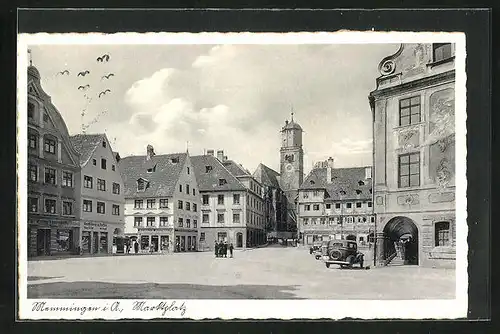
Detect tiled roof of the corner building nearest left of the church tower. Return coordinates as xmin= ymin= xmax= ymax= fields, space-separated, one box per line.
xmin=191 ymin=155 xmax=246 ymax=191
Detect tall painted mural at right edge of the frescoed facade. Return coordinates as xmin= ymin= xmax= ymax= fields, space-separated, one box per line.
xmin=426 ymin=88 xmax=455 ymax=190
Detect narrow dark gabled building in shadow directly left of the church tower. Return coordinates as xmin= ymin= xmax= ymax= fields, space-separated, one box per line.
xmin=253 ymin=163 xmax=295 ymax=240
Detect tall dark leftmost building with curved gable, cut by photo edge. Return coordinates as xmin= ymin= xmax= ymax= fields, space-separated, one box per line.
xmin=27 ymin=66 xmax=80 ymax=257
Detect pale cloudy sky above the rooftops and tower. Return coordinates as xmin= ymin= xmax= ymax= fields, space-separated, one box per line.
xmin=30 ymin=44 xmax=399 ymax=172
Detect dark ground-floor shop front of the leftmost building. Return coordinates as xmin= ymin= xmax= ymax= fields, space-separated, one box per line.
xmin=28 ymin=219 xmax=79 ymax=257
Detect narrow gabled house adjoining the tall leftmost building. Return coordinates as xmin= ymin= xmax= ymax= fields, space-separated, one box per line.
xmin=70 ymin=134 xmax=125 ymax=254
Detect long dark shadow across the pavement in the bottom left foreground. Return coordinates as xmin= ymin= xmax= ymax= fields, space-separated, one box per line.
xmin=27 ymin=282 xmax=303 ymax=299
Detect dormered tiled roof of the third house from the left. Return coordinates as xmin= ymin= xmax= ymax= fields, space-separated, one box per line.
xmin=118 ymin=153 xmax=187 ymax=198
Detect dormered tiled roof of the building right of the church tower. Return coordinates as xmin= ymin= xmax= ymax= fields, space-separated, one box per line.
xmin=300 ymin=167 xmax=372 ymax=200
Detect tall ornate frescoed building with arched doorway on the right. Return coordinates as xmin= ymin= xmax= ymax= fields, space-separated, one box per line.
xmin=369 ymin=43 xmax=456 ymax=267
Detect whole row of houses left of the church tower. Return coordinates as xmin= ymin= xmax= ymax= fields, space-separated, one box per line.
xmin=28 ymin=66 xmax=290 ymax=257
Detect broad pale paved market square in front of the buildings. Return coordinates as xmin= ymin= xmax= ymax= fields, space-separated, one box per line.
xmin=28 ymin=247 xmax=455 ymax=299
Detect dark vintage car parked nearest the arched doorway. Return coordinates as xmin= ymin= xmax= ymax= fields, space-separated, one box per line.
xmin=322 ymin=240 xmax=364 ymax=268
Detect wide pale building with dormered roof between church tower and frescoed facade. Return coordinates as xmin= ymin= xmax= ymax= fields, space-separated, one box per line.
xmin=298 ymin=158 xmax=375 ymax=245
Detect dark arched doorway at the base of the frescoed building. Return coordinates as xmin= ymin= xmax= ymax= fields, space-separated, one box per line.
xmin=384 ymin=216 xmax=419 ymax=265
